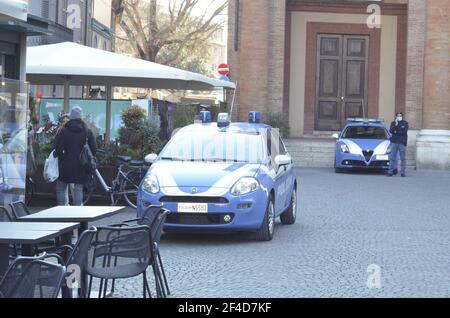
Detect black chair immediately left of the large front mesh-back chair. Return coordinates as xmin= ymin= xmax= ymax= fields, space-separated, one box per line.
xmin=48 ymin=227 xmax=97 ymax=298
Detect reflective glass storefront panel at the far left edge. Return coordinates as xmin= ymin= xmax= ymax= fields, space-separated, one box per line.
xmin=0 ymin=78 xmax=28 ymax=205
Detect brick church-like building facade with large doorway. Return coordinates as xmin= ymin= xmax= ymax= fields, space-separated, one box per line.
xmin=228 ymin=0 xmax=450 ymax=169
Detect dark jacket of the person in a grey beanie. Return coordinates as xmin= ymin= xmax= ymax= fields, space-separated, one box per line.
xmin=55 ymin=119 xmax=97 ymax=184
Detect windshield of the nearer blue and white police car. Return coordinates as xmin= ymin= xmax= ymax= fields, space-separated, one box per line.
xmin=160 ymin=130 xmax=266 ymax=163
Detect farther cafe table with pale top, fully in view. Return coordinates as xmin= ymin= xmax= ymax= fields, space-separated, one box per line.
xmin=19 ymin=206 xmax=125 ymax=234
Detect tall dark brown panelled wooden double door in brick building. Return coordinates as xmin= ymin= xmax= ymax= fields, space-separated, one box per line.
xmin=315 ymin=34 xmax=369 ymax=131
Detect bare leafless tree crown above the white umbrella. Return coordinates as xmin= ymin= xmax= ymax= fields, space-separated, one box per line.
xmin=117 ymin=0 xmax=228 ymax=72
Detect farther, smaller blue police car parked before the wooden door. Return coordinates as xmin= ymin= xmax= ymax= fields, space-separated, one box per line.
xmin=335 ymin=118 xmax=390 ymax=173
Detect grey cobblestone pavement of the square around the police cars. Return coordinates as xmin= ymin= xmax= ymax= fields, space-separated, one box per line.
xmin=34 ymin=169 xmax=450 ymax=297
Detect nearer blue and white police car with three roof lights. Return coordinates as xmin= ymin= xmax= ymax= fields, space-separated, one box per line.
xmin=138 ymin=112 xmax=298 ymax=241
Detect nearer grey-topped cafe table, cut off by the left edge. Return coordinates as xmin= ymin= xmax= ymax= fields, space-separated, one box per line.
xmin=0 ymin=222 xmax=79 ymax=275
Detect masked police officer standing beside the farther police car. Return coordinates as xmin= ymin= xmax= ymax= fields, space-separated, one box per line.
xmin=388 ymin=113 xmax=409 ymax=178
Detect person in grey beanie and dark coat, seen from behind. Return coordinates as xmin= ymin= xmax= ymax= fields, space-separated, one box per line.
xmin=55 ymin=106 xmax=97 ymax=206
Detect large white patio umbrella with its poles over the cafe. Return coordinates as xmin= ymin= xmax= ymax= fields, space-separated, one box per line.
xmin=27 ymin=42 xmax=236 ymax=138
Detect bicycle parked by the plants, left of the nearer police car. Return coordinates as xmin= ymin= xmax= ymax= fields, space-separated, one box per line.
xmin=84 ymin=150 xmax=148 ymax=208
